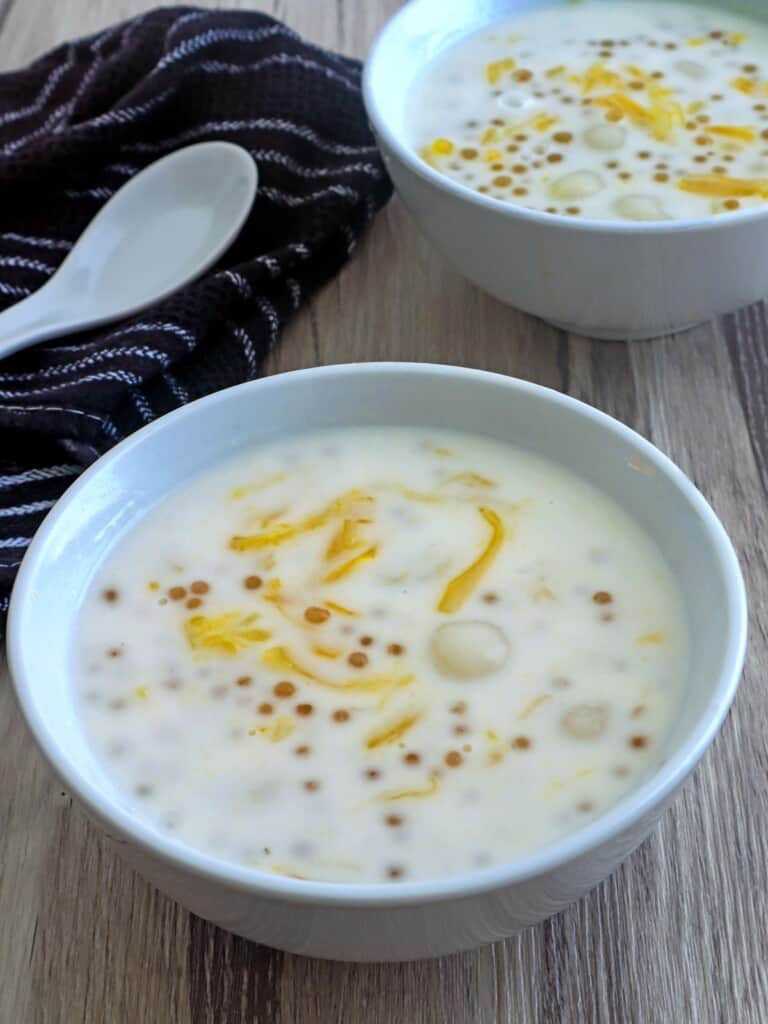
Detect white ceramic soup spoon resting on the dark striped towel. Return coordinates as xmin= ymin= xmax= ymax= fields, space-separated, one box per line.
xmin=0 ymin=142 xmax=258 ymax=358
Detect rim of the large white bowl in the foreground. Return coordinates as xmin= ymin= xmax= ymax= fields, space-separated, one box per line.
xmin=7 ymin=361 xmax=748 ymax=907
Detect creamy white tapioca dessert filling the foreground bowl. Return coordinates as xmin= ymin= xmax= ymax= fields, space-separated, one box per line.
xmin=73 ymin=428 xmax=687 ymax=883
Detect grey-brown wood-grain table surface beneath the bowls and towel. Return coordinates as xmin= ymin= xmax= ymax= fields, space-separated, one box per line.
xmin=0 ymin=0 xmax=768 ymax=1024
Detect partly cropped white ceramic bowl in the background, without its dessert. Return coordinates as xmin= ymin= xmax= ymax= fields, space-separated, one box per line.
xmin=364 ymin=0 xmax=768 ymax=339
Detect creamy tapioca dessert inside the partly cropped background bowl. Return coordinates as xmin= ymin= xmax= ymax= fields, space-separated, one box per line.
xmin=410 ymin=0 xmax=768 ymax=221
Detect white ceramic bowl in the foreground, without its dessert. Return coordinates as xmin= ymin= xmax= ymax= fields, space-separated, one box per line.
xmin=8 ymin=364 xmax=746 ymax=961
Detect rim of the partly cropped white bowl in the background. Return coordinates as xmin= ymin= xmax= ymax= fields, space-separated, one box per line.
xmin=362 ymin=0 xmax=768 ymax=236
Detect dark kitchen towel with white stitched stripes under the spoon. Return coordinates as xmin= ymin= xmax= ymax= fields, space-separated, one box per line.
xmin=0 ymin=7 xmax=390 ymax=620
